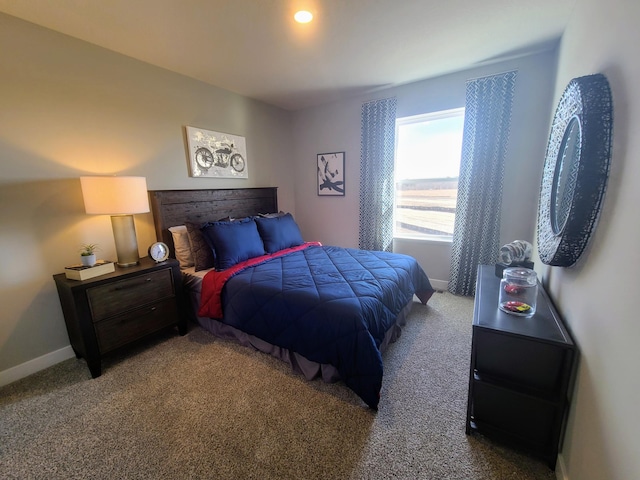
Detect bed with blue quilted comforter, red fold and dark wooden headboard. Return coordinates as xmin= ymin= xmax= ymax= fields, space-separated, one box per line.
xmin=150 ymin=188 xmax=433 ymax=409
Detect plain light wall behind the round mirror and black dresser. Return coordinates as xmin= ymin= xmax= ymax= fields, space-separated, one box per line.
xmin=541 ymin=0 xmax=640 ymax=480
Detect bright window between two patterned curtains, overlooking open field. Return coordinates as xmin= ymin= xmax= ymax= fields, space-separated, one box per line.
xmin=393 ymin=108 xmax=464 ymax=241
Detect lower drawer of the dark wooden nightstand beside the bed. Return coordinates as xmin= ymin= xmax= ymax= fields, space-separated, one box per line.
xmin=94 ymin=298 xmax=178 ymax=353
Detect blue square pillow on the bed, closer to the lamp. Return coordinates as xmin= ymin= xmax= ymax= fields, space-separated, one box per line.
xmin=201 ymin=219 xmax=265 ymax=270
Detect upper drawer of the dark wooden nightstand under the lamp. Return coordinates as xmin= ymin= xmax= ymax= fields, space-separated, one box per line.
xmin=87 ymin=268 xmax=174 ymax=322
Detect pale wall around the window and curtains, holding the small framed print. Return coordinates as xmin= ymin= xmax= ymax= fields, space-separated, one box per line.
xmin=293 ymin=50 xmax=556 ymax=288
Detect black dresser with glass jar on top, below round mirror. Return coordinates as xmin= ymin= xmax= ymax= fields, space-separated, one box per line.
xmin=466 ymin=265 xmax=577 ymax=469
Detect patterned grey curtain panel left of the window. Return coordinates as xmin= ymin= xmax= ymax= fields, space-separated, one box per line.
xmin=358 ymin=98 xmax=397 ymax=252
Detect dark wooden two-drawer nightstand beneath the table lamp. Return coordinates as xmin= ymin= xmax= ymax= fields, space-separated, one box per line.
xmin=53 ymin=257 xmax=187 ymax=378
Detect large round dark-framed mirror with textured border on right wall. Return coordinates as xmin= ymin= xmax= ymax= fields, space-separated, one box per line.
xmin=538 ymin=74 xmax=613 ymax=267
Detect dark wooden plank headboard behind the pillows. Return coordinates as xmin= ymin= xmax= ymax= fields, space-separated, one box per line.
xmin=149 ymin=187 xmax=278 ymax=258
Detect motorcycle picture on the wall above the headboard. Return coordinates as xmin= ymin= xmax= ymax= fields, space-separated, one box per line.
xmin=186 ymin=127 xmax=249 ymax=178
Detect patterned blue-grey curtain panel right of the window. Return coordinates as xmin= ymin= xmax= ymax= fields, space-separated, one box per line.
xmin=449 ymin=71 xmax=517 ymax=295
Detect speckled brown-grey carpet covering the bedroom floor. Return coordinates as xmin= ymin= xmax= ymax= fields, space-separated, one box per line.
xmin=0 ymin=293 xmax=555 ymax=480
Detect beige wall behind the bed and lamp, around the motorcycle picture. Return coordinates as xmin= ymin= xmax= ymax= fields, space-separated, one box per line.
xmin=0 ymin=14 xmax=295 ymax=378
